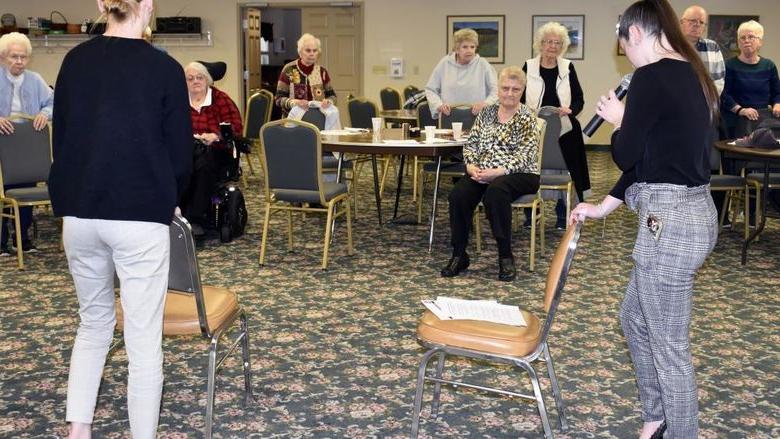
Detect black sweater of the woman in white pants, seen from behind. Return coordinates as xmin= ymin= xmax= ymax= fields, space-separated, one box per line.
xmin=49 ymin=36 xmax=193 ymax=224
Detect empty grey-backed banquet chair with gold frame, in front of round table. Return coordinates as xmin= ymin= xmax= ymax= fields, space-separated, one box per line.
xmin=260 ymin=119 xmax=353 ymax=270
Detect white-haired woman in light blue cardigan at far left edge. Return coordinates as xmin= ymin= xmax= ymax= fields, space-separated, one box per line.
xmin=0 ymin=32 xmax=54 ymax=256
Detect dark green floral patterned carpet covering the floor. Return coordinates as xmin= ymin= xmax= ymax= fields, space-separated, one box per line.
xmin=0 ymin=152 xmax=780 ymax=438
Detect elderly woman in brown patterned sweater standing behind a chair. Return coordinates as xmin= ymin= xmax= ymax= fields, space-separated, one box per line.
xmin=274 ymin=33 xmax=341 ymax=130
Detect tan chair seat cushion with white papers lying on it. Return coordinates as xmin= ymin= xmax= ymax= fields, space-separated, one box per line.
xmin=417 ymin=309 xmax=542 ymax=357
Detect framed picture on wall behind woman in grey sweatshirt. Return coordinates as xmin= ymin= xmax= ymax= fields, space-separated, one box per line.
xmin=447 ymin=15 xmax=505 ymax=64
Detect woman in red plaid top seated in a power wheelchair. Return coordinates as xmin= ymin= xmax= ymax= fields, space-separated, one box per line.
xmin=179 ymin=61 xmax=244 ymax=235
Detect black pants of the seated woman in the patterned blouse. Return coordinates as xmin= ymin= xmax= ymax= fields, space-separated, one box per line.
xmin=449 ymin=174 xmax=539 ymax=258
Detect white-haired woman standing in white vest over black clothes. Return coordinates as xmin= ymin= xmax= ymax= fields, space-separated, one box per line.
xmin=521 ymin=21 xmax=590 ymax=229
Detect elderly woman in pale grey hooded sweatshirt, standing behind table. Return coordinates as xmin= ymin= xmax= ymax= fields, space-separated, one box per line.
xmin=425 ymin=28 xmax=497 ymax=119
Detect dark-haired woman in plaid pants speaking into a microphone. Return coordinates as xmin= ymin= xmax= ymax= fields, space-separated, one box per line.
xmin=571 ymin=0 xmax=718 ymax=439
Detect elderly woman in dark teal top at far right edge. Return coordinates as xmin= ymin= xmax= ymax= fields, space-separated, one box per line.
xmin=721 ymin=20 xmax=780 ymax=138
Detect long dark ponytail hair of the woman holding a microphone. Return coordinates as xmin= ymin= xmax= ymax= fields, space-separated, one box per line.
xmin=618 ymin=0 xmax=720 ymax=121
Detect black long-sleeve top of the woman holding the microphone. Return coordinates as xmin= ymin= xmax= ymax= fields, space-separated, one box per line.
xmin=610 ymin=58 xmax=713 ymax=200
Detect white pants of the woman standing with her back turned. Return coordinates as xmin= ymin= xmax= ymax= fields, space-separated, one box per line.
xmin=63 ymin=217 xmax=170 ymax=439
